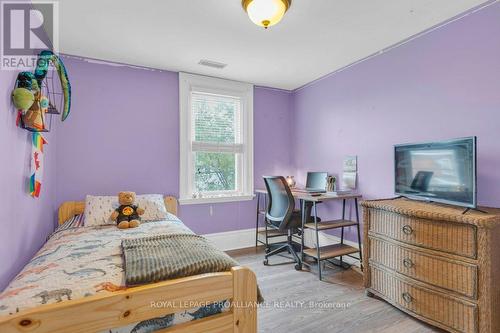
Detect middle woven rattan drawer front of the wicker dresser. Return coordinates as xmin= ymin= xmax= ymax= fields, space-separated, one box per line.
xmin=370 ymin=237 xmax=477 ymax=299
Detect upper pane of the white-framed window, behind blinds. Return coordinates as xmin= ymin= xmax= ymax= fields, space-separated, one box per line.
xmin=191 ymin=93 xmax=240 ymax=143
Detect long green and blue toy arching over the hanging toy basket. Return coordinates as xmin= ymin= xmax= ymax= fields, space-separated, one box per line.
xmin=35 ymin=50 xmax=71 ymax=121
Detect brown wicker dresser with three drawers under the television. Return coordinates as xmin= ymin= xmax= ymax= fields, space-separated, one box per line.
xmin=362 ymin=199 xmax=500 ymax=333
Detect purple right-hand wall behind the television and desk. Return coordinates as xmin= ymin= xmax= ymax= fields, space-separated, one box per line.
xmin=293 ymin=4 xmax=500 ymax=239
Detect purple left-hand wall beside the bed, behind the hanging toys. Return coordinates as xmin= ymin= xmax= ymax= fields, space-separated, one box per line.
xmin=0 ymin=70 xmax=57 ymax=290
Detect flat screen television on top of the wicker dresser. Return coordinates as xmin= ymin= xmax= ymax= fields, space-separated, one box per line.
xmin=394 ymin=137 xmax=477 ymax=208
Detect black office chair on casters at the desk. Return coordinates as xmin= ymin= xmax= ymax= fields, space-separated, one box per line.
xmin=263 ymin=176 xmax=302 ymax=270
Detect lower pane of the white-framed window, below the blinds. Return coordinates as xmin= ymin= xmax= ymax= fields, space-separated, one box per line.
xmin=194 ymin=152 xmax=236 ymax=192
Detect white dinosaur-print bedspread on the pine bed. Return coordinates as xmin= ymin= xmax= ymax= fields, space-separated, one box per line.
xmin=0 ymin=215 xmax=226 ymax=333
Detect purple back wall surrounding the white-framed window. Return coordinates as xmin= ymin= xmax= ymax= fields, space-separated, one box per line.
xmin=57 ymin=57 xmax=291 ymax=234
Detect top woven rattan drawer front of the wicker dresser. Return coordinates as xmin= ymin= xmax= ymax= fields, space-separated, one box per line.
xmin=370 ymin=209 xmax=477 ymax=258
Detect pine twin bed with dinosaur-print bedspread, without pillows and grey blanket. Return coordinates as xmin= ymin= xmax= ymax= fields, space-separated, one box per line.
xmin=0 ymin=197 xmax=257 ymax=333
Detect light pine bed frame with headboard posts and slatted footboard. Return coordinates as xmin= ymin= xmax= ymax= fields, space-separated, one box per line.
xmin=0 ymin=197 xmax=257 ymax=333
